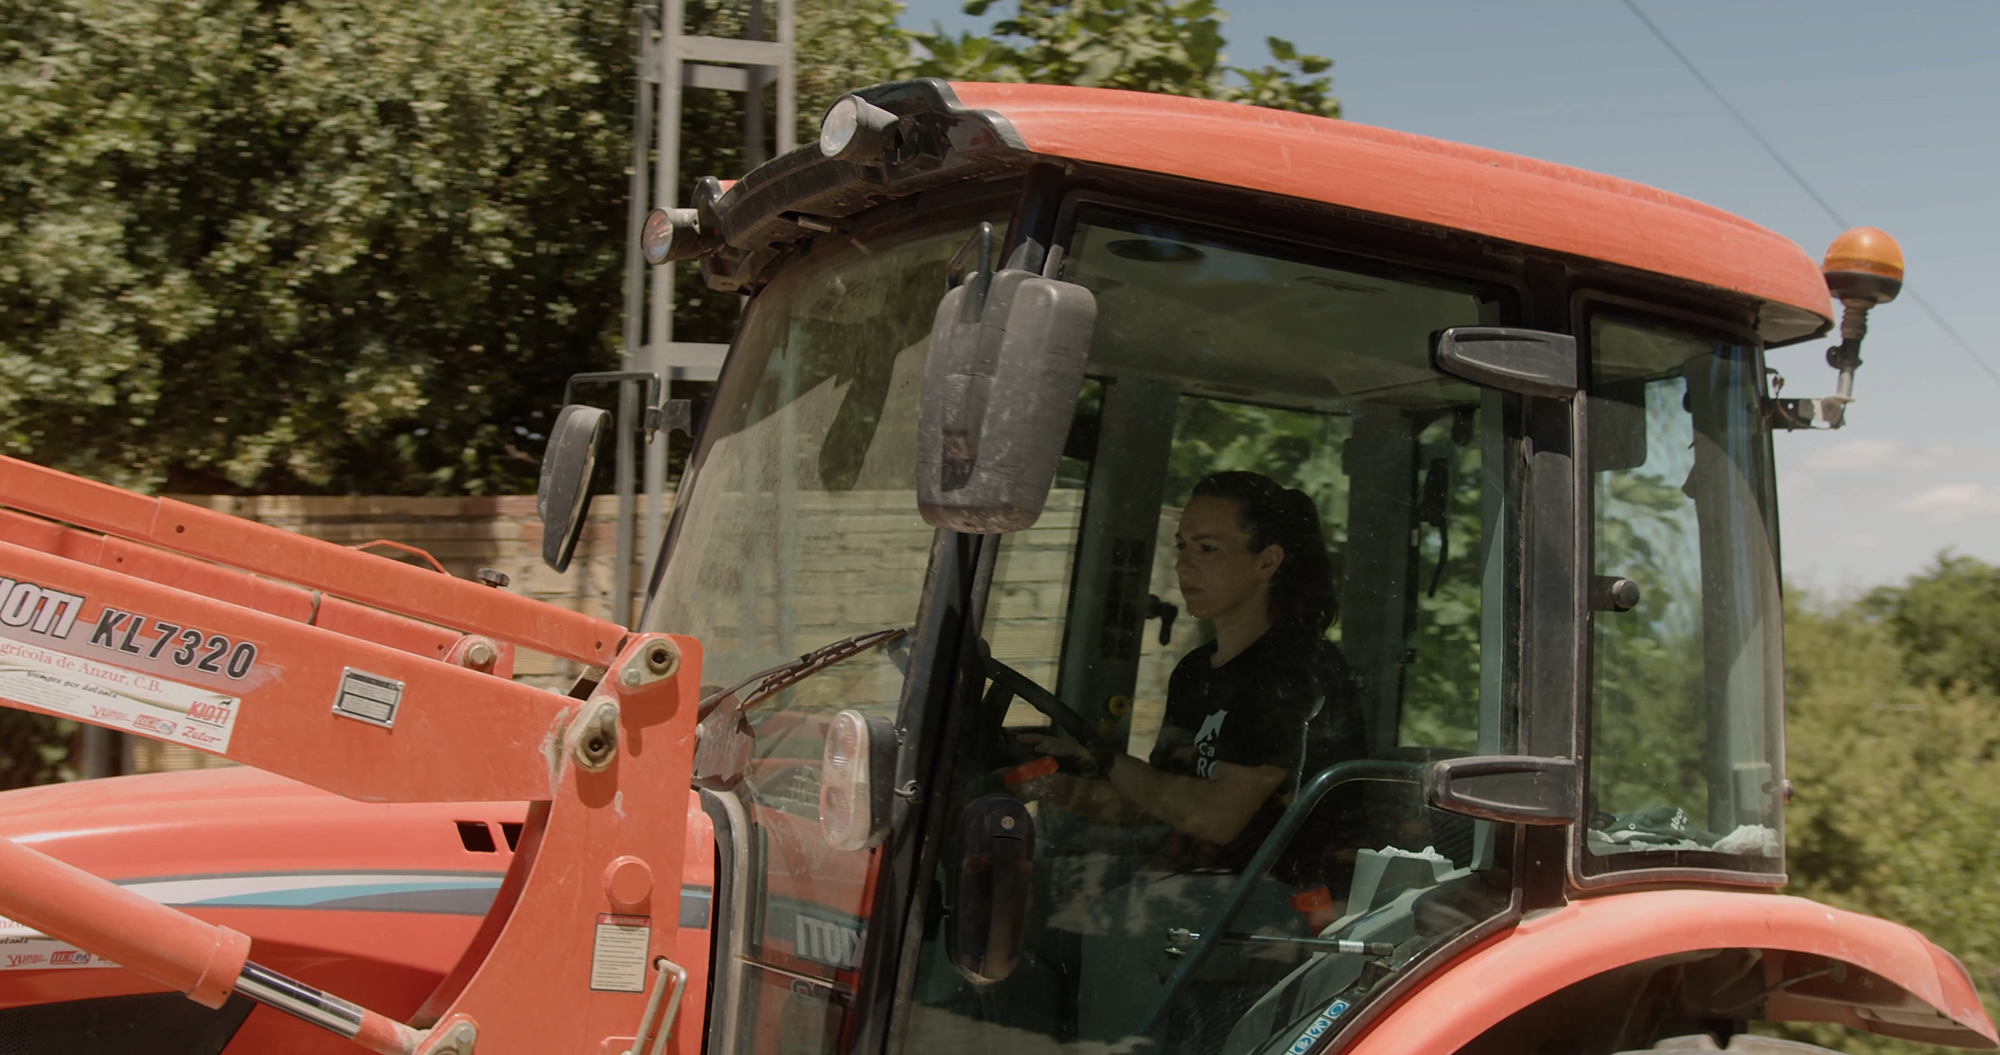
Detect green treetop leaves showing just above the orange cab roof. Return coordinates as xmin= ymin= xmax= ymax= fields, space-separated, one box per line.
xmin=914 ymin=0 xmax=1340 ymax=118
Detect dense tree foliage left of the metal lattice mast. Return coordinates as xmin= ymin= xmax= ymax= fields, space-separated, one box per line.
xmin=0 ymin=0 xmax=632 ymax=494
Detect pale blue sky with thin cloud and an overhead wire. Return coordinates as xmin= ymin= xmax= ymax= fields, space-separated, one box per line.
xmin=904 ymin=0 xmax=2000 ymax=597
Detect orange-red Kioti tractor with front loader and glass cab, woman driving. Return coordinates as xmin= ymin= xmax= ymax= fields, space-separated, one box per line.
xmin=0 ymin=80 xmax=1996 ymax=1055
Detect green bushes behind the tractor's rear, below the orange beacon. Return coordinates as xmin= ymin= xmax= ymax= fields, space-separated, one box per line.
xmin=1786 ymin=575 xmax=2000 ymax=1055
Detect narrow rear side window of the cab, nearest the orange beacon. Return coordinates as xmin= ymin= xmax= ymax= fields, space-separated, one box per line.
xmin=1588 ymin=318 xmax=1784 ymax=871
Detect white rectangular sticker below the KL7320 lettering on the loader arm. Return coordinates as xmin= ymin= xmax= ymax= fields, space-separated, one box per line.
xmin=0 ymin=639 xmax=240 ymax=753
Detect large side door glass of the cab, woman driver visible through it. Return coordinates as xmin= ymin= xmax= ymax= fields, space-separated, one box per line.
xmin=910 ymin=212 xmax=1514 ymax=1055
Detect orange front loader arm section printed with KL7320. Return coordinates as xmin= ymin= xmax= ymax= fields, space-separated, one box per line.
xmin=0 ymin=541 xmax=580 ymax=801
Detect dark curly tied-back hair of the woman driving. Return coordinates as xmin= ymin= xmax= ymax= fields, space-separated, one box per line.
xmin=1190 ymin=470 xmax=1340 ymax=633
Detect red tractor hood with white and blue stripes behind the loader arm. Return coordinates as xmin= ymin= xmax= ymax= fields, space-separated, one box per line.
xmin=0 ymin=767 xmax=714 ymax=1053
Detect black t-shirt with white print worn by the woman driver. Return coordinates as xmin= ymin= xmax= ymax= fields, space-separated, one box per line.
xmin=1148 ymin=627 xmax=1364 ymax=869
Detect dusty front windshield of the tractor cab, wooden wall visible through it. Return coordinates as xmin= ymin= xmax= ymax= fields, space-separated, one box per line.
xmin=646 ymin=205 xmax=1008 ymax=1055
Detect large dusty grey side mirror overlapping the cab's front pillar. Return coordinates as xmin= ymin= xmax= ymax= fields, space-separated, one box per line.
xmin=916 ymin=224 xmax=1098 ymax=535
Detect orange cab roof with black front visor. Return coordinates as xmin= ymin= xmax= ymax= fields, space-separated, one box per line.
xmin=694 ymin=80 xmax=1830 ymax=344
